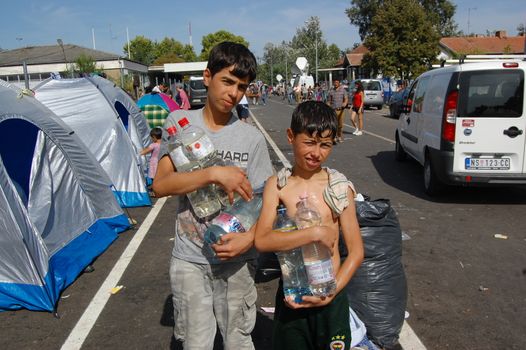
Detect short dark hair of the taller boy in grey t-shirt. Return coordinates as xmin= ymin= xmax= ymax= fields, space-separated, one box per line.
xmin=206 ymin=41 xmax=257 ymax=81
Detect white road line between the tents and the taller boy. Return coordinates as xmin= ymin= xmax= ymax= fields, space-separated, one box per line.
xmin=61 ymin=197 xmax=167 ymax=350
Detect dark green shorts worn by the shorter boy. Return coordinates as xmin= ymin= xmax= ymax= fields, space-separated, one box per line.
xmin=272 ymin=280 xmax=351 ymax=350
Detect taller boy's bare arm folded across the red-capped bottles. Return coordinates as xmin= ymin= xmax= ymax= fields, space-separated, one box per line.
xmin=153 ymin=156 xmax=252 ymax=200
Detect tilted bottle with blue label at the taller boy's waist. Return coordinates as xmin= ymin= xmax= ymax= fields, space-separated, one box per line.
xmin=204 ymin=191 xmax=263 ymax=244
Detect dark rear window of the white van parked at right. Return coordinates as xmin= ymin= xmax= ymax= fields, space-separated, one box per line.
xmin=458 ymin=70 xmax=524 ymax=118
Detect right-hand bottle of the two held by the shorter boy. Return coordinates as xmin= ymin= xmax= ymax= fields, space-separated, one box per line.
xmin=295 ymin=196 xmax=336 ymax=297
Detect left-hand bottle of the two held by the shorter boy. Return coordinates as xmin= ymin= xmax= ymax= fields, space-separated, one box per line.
xmin=274 ymin=205 xmax=312 ymax=303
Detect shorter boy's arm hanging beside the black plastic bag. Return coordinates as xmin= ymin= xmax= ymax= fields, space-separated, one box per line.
xmin=336 ymin=191 xmax=364 ymax=293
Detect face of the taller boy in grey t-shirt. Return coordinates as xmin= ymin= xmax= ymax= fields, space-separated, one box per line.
xmin=203 ymin=66 xmax=249 ymax=113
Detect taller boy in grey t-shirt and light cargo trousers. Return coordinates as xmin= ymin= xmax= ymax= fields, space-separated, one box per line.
xmin=153 ymin=41 xmax=273 ymax=350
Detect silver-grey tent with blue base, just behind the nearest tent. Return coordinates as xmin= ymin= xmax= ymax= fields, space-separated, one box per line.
xmin=35 ymin=78 xmax=151 ymax=207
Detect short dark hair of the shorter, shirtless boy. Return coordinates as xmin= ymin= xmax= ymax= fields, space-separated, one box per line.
xmin=290 ymin=101 xmax=338 ymax=139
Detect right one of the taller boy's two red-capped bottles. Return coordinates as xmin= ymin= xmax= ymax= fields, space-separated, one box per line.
xmin=178 ymin=117 xmax=223 ymax=218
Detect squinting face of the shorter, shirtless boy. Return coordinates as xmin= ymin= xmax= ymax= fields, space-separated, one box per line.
xmin=287 ymin=128 xmax=333 ymax=171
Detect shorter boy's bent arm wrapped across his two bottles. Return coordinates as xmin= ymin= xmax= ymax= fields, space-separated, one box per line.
xmin=255 ymin=176 xmax=337 ymax=252
